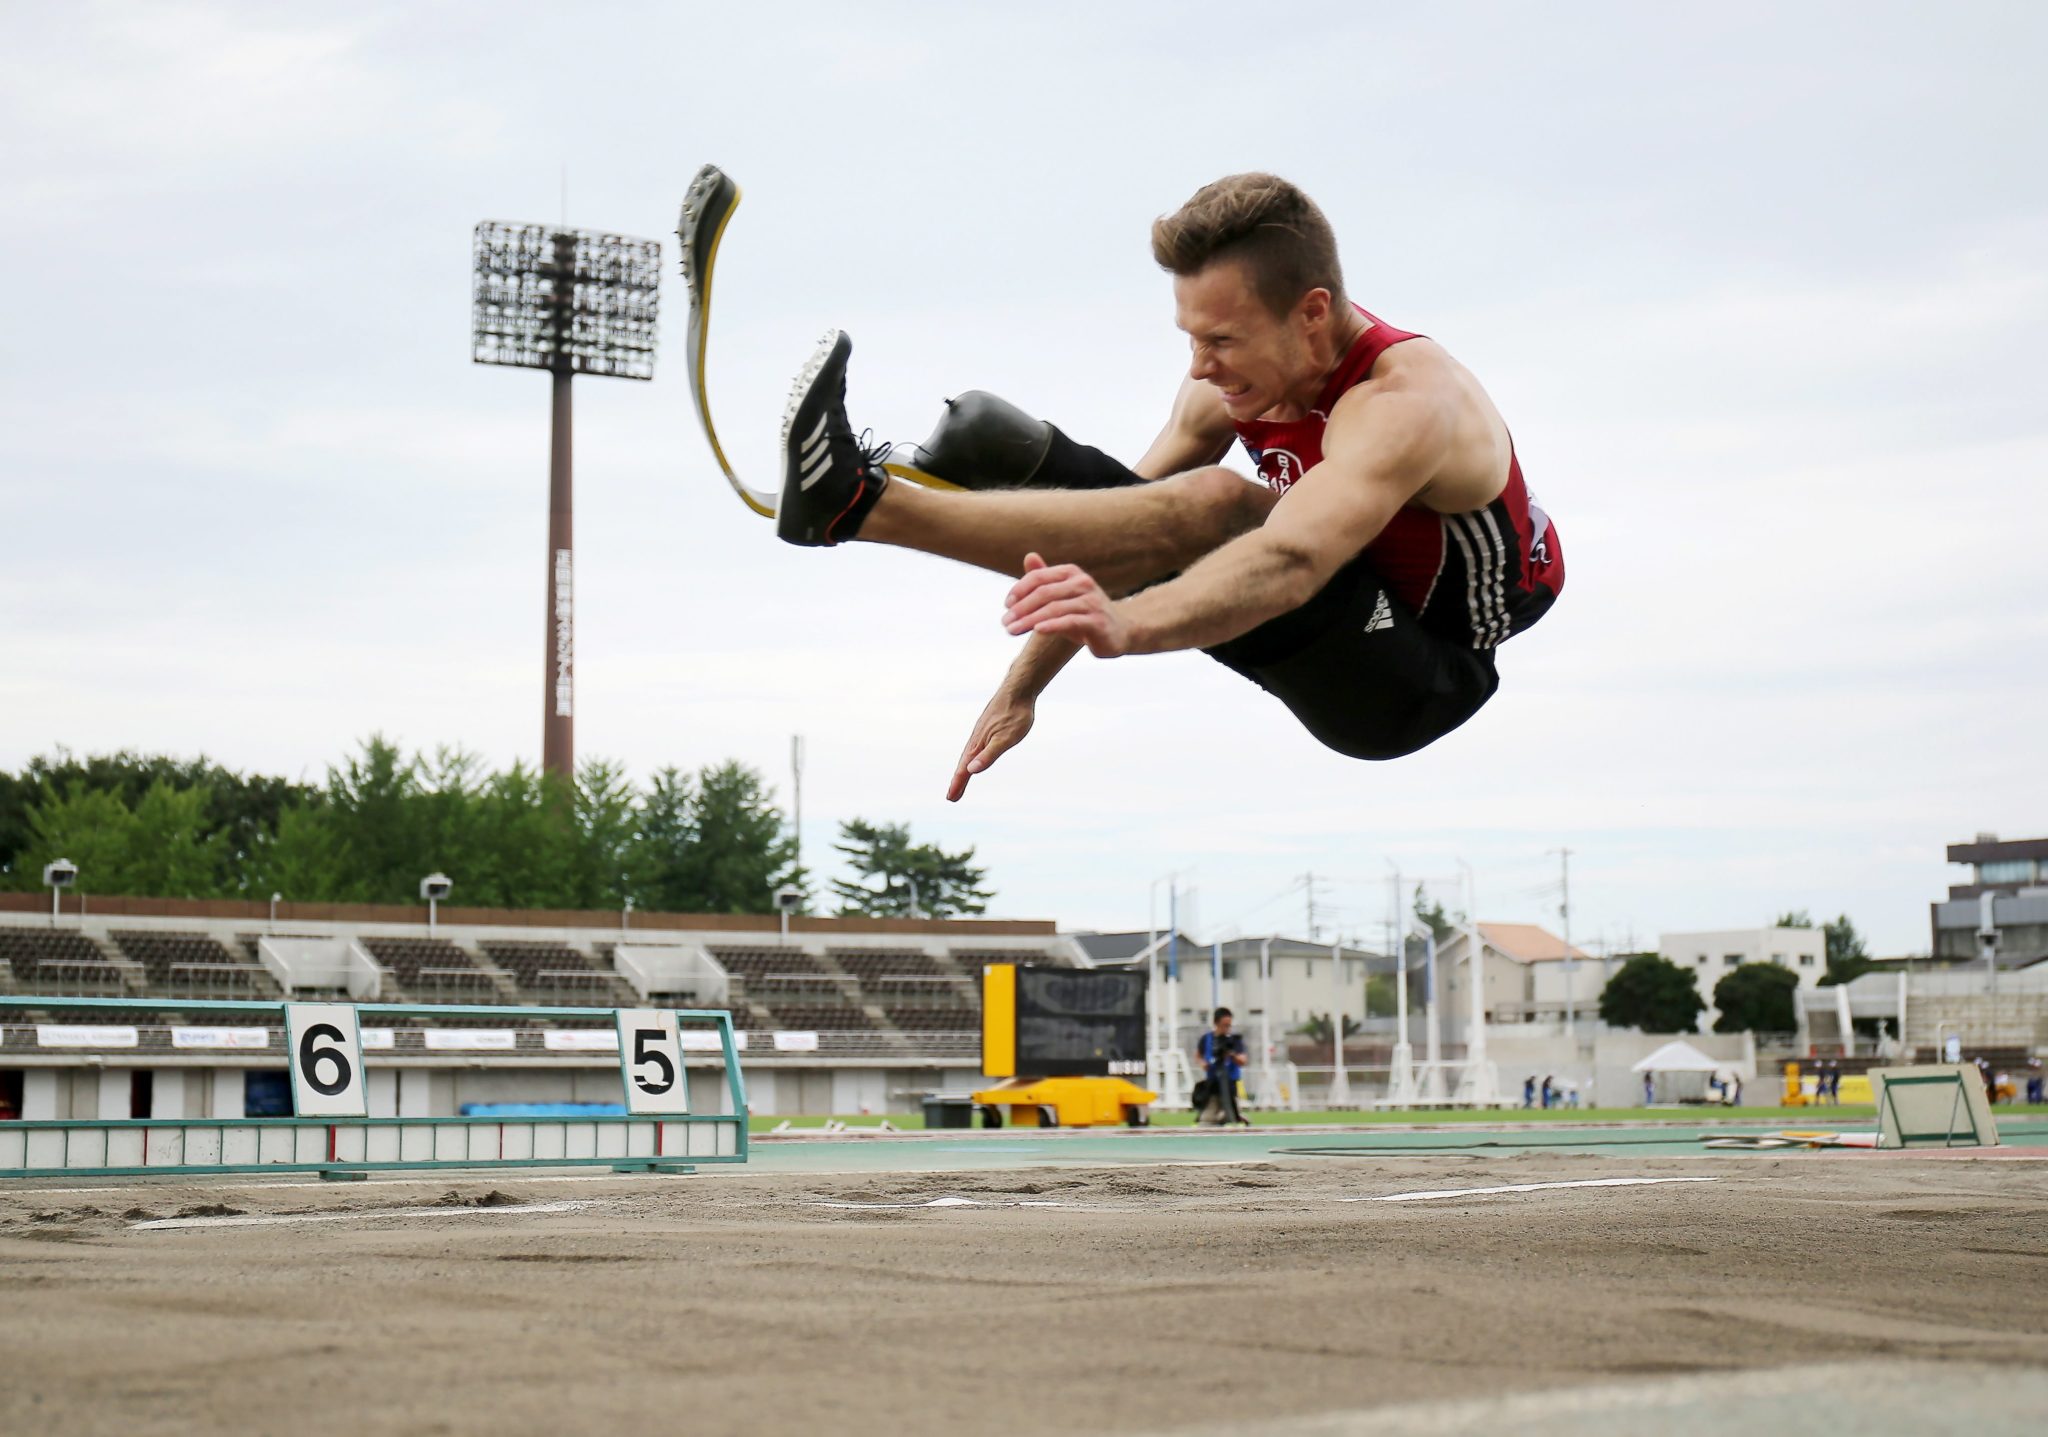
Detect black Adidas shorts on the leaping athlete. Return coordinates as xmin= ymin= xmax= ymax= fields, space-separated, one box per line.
xmin=1204 ymin=557 xmax=1501 ymax=759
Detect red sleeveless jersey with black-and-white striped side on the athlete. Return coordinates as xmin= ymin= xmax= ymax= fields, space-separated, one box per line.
xmin=1235 ymin=315 xmax=1565 ymax=649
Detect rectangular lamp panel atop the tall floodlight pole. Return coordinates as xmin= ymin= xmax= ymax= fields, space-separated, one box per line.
xmin=471 ymin=219 xmax=662 ymax=379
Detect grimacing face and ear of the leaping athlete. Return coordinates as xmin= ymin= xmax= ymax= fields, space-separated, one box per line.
xmin=1174 ymin=260 xmax=1329 ymax=422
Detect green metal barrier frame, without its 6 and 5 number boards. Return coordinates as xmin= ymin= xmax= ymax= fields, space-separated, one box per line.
xmin=0 ymin=997 xmax=748 ymax=1179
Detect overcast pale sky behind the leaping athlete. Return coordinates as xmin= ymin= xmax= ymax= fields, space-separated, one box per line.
xmin=0 ymin=2 xmax=2048 ymax=952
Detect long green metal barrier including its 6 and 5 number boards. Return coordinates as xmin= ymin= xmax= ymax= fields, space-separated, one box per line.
xmin=0 ymin=997 xmax=748 ymax=1179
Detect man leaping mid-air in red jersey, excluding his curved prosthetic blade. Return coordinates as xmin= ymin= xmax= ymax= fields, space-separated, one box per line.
xmin=776 ymin=174 xmax=1565 ymax=798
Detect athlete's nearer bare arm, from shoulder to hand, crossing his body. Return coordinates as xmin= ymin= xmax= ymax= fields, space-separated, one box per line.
xmin=1004 ymin=383 xmax=1456 ymax=659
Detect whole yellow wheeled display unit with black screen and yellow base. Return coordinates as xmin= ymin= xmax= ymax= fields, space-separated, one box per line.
xmin=975 ymin=962 xmax=1159 ymax=1128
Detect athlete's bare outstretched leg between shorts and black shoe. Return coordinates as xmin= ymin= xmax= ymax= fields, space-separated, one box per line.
xmin=858 ymin=469 xmax=1276 ymax=592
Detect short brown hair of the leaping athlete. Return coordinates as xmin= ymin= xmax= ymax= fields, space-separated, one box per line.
xmin=1153 ymin=174 xmax=1343 ymax=315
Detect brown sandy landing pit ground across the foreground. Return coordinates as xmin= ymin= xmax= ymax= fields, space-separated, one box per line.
xmin=0 ymin=1155 xmax=2048 ymax=1437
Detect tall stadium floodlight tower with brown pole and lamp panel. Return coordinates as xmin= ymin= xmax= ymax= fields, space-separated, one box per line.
xmin=471 ymin=219 xmax=662 ymax=778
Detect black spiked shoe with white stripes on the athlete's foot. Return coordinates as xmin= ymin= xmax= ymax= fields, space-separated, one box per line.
xmin=774 ymin=330 xmax=891 ymax=545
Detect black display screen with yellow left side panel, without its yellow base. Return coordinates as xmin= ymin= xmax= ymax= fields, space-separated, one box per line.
xmin=981 ymin=962 xmax=1147 ymax=1077
